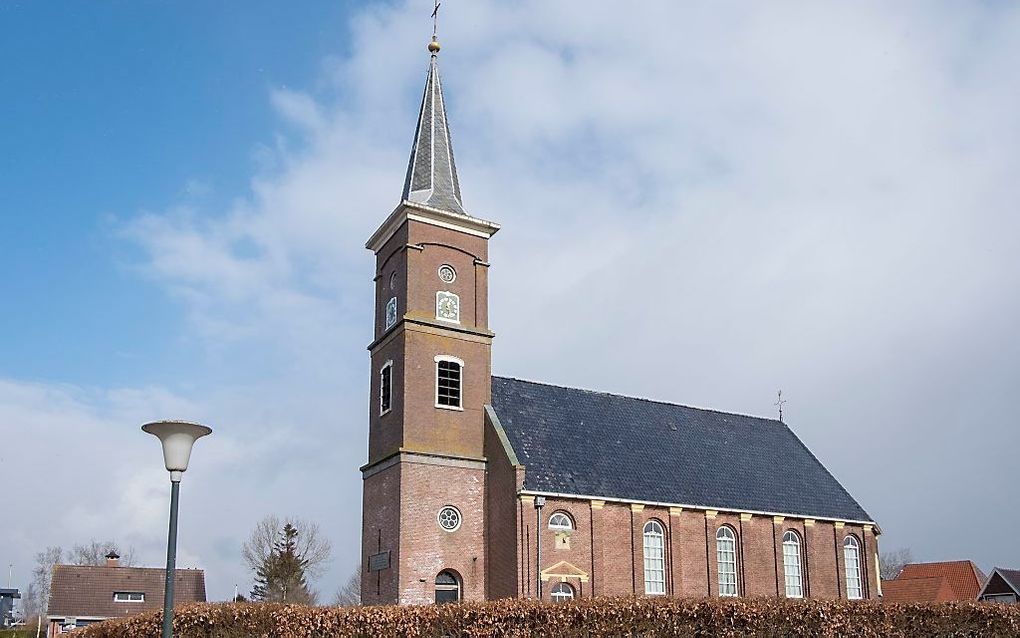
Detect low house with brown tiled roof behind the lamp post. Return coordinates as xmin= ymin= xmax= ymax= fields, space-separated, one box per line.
xmin=47 ymin=552 xmax=205 ymax=637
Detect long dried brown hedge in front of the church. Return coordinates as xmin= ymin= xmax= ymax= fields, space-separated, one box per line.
xmin=75 ymin=598 xmax=1020 ymax=638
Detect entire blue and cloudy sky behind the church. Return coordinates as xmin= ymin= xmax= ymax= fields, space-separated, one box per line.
xmin=0 ymin=0 xmax=1020 ymax=599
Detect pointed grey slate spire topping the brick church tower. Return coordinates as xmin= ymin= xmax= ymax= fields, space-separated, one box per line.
xmin=403 ymin=36 xmax=467 ymax=215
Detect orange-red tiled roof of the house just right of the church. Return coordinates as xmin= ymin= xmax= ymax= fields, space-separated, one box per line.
xmin=882 ymin=560 xmax=985 ymax=602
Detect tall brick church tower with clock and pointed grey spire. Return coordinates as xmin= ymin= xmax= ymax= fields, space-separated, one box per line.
xmin=361 ymin=37 xmax=499 ymax=604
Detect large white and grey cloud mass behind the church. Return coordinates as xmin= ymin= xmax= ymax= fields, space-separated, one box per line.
xmin=0 ymin=0 xmax=1020 ymax=597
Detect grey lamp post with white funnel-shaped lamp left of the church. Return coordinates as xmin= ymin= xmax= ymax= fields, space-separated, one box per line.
xmin=142 ymin=421 xmax=212 ymax=638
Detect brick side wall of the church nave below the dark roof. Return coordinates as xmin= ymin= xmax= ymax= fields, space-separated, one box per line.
xmin=517 ymin=494 xmax=877 ymax=600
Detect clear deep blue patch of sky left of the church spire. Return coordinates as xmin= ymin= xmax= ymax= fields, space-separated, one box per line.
xmin=0 ymin=2 xmax=359 ymax=385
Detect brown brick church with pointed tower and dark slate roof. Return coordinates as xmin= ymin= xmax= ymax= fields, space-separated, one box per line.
xmin=361 ymin=40 xmax=881 ymax=604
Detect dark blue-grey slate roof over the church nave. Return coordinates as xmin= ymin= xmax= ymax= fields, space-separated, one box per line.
xmin=492 ymin=377 xmax=871 ymax=521
